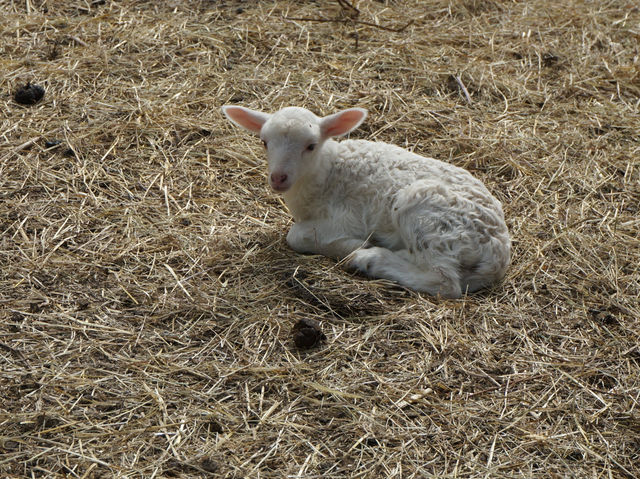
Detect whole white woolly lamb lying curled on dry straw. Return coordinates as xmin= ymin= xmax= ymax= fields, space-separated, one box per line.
xmin=222 ymin=105 xmax=511 ymax=298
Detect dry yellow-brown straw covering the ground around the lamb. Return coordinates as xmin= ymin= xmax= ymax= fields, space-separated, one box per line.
xmin=0 ymin=0 xmax=640 ymax=478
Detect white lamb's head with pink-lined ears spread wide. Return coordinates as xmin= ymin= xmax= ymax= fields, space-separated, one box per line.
xmin=222 ymin=106 xmax=367 ymax=193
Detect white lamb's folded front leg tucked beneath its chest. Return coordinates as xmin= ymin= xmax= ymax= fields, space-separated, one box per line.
xmin=287 ymin=221 xmax=367 ymax=260
